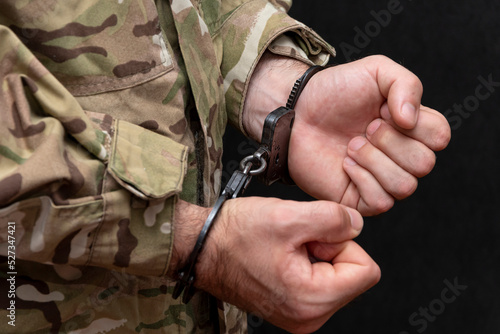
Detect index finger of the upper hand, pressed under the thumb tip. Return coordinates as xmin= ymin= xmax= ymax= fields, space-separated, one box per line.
xmin=380 ymin=104 xmax=451 ymax=151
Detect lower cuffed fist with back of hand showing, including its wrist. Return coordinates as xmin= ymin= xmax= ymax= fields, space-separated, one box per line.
xmin=171 ymin=197 xmax=380 ymax=333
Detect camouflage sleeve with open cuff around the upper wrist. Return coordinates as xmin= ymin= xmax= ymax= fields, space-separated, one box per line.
xmin=218 ymin=0 xmax=335 ymax=133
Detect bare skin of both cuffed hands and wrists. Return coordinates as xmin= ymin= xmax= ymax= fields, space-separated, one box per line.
xmin=169 ymin=54 xmax=450 ymax=333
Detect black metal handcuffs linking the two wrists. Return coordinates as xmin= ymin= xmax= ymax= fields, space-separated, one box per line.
xmin=172 ymin=65 xmax=325 ymax=304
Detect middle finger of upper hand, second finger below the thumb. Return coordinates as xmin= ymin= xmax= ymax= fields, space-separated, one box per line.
xmin=366 ymin=119 xmax=436 ymax=177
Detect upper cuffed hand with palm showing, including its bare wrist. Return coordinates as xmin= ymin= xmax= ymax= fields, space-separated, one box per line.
xmin=243 ymin=55 xmax=450 ymax=215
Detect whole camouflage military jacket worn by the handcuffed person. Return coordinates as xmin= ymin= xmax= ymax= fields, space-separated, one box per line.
xmin=0 ymin=0 xmax=333 ymax=333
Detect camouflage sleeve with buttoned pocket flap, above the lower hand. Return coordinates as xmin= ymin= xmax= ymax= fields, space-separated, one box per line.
xmin=0 ymin=26 xmax=187 ymax=275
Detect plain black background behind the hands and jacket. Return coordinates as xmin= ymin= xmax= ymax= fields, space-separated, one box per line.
xmin=224 ymin=0 xmax=500 ymax=334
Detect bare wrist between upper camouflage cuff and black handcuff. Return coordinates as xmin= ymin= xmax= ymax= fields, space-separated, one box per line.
xmin=243 ymin=52 xmax=309 ymax=141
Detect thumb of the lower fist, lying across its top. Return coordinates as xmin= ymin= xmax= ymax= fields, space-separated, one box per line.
xmin=288 ymin=201 xmax=363 ymax=245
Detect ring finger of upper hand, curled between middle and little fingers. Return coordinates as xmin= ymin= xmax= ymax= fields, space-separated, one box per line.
xmin=347 ymin=137 xmax=418 ymax=199
